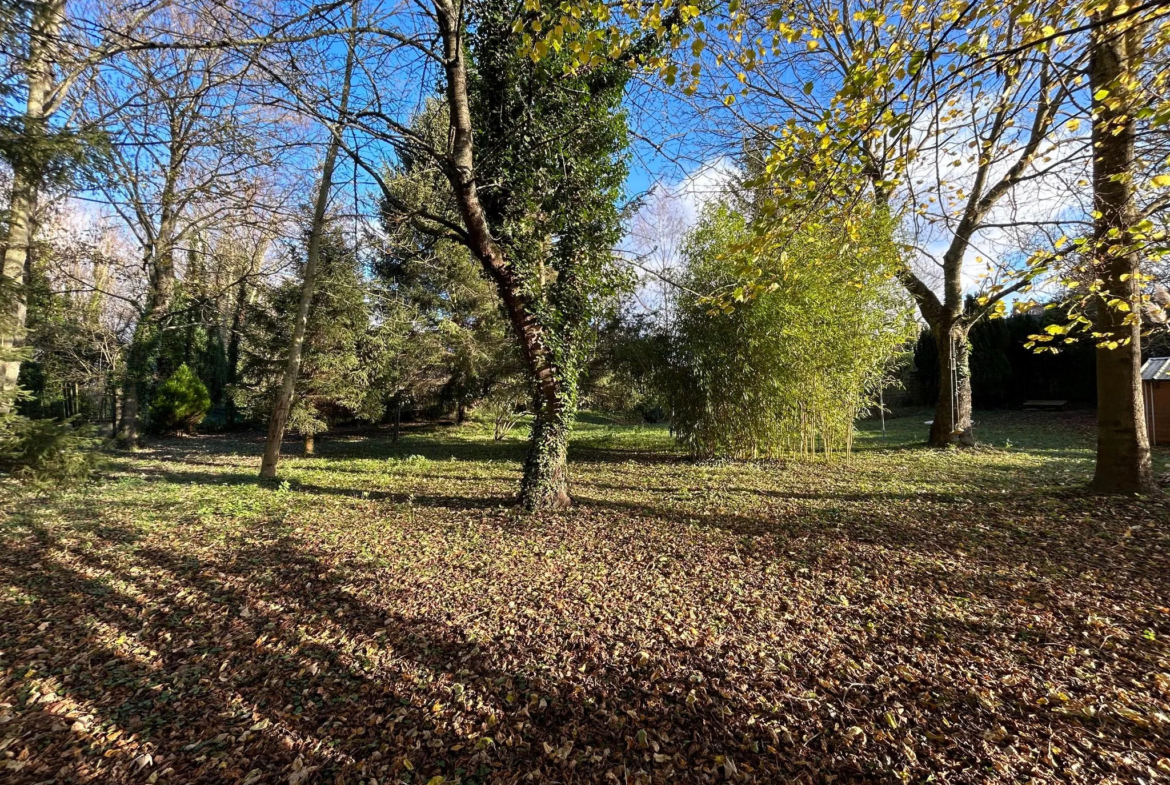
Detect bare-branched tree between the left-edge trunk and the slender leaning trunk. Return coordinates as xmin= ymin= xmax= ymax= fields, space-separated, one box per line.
xmin=85 ymin=11 xmax=280 ymax=449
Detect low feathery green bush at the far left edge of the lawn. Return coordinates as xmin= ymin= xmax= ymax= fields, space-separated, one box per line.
xmin=0 ymin=414 xmax=99 ymax=488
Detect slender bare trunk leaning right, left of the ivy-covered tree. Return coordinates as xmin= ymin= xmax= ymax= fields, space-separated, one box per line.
xmin=260 ymin=29 xmax=357 ymax=478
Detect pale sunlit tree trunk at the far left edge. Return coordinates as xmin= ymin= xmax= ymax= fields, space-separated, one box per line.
xmin=0 ymin=0 xmax=64 ymax=413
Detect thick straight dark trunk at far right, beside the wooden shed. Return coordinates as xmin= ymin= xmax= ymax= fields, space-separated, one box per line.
xmin=1089 ymin=9 xmax=1156 ymax=494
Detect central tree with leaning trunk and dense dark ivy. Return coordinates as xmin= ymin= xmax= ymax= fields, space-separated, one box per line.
xmin=348 ymin=0 xmax=631 ymax=509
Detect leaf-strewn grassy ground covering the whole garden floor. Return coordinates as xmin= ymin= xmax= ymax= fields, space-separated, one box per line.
xmin=0 ymin=413 xmax=1170 ymax=785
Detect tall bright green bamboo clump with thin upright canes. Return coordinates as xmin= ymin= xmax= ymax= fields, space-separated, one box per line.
xmin=668 ymin=205 xmax=914 ymax=459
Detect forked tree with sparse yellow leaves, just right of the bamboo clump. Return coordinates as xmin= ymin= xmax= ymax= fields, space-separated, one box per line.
xmin=716 ymin=0 xmax=1087 ymax=446
